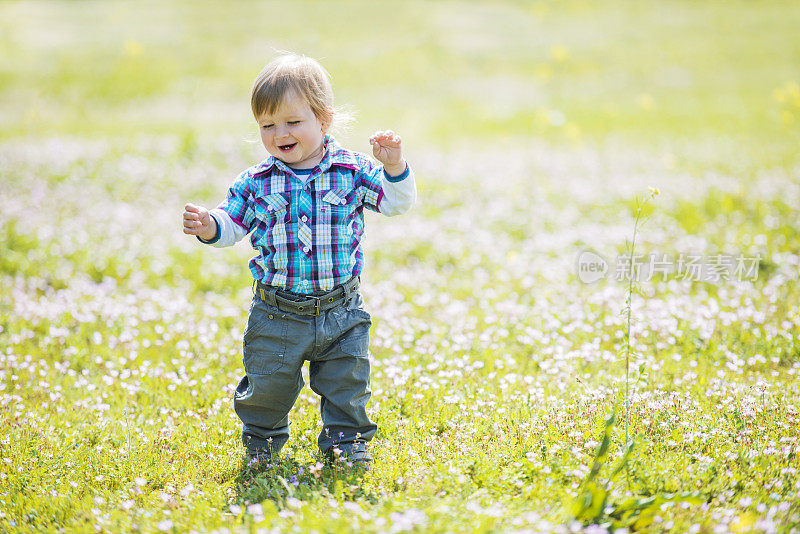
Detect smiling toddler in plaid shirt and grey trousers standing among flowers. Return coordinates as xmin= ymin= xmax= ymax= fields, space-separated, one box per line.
xmin=183 ymin=55 xmax=416 ymax=469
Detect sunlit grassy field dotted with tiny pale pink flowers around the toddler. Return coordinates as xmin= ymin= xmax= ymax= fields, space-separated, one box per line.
xmin=0 ymin=0 xmax=800 ymax=533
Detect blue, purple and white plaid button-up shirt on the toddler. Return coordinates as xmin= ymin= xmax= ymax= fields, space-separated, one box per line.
xmin=202 ymin=136 xmax=413 ymax=293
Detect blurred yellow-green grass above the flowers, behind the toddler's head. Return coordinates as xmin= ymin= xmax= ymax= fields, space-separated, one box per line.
xmin=0 ymin=1 xmax=800 ymax=146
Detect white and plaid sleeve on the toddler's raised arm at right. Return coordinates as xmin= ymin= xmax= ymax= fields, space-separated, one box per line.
xmin=357 ymin=161 xmax=417 ymax=217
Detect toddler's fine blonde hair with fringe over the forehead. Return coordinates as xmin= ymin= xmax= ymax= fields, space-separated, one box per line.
xmin=250 ymin=54 xmax=333 ymax=124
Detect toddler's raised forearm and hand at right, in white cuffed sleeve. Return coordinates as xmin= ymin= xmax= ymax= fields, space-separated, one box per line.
xmin=364 ymin=130 xmax=417 ymax=217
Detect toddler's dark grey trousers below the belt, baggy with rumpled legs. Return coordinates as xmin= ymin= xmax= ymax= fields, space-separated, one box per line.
xmin=233 ymin=291 xmax=377 ymax=456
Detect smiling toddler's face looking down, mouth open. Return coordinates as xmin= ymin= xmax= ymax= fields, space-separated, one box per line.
xmin=257 ymin=91 xmax=328 ymax=169
